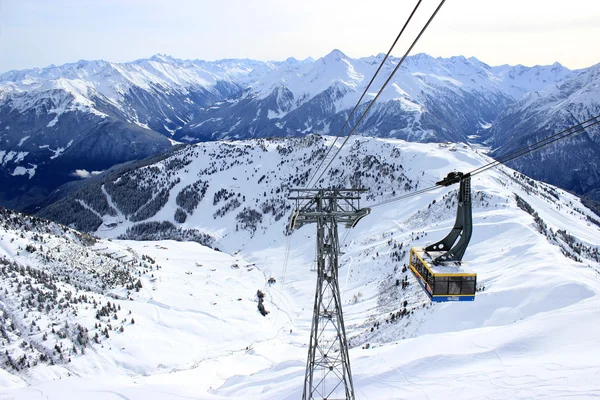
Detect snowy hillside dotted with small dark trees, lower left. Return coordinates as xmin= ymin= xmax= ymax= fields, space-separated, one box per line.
xmin=0 ymin=208 xmax=160 ymax=378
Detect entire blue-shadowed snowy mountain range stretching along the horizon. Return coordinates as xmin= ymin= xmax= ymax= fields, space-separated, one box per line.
xmin=0 ymin=50 xmax=600 ymax=209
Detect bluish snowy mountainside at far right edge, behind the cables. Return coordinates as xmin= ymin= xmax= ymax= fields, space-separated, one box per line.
xmin=486 ymin=64 xmax=600 ymax=195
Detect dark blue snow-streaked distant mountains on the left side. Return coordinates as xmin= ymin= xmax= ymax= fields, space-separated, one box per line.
xmin=0 ymin=55 xmax=269 ymax=209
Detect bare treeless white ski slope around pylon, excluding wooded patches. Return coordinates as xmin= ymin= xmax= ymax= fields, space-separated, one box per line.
xmin=0 ymin=138 xmax=600 ymax=399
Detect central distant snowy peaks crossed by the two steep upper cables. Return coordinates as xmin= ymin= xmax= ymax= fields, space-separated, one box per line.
xmin=175 ymin=50 xmax=572 ymax=142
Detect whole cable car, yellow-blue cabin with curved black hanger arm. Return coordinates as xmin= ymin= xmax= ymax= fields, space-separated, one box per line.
xmin=409 ymin=172 xmax=477 ymax=301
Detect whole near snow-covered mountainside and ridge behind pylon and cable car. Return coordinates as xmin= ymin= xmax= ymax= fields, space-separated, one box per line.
xmin=0 ymin=135 xmax=600 ymax=400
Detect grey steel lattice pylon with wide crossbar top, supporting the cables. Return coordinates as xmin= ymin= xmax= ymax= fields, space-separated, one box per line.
xmin=290 ymin=189 xmax=370 ymax=400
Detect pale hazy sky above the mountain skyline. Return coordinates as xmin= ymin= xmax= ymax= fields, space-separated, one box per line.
xmin=0 ymin=0 xmax=600 ymax=72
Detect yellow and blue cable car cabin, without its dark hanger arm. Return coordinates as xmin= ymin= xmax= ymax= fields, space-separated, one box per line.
xmin=409 ymin=247 xmax=477 ymax=301
